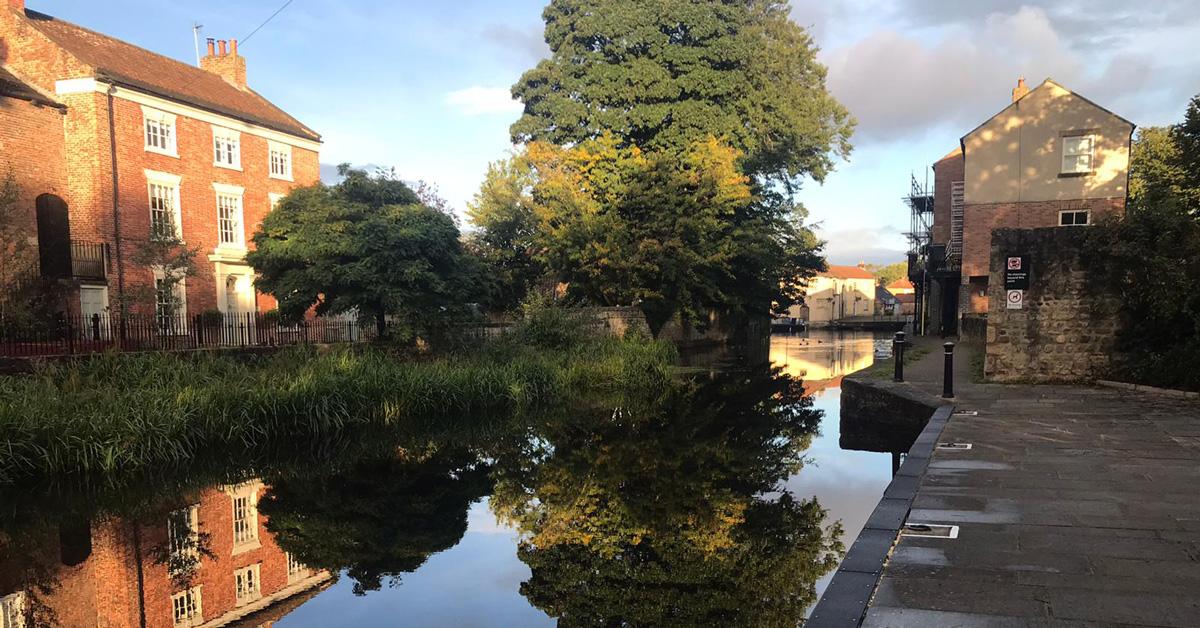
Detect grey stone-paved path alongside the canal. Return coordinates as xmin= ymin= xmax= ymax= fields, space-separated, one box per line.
xmin=863 ymin=339 xmax=1200 ymax=627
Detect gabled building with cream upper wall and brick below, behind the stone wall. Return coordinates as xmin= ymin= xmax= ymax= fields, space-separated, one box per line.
xmin=925 ymin=79 xmax=1135 ymax=331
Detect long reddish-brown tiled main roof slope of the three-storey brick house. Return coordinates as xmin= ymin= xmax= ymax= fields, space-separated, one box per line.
xmin=25 ymin=10 xmax=320 ymax=142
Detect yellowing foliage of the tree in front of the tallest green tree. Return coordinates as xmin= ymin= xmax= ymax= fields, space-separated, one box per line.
xmin=472 ymin=133 xmax=821 ymax=335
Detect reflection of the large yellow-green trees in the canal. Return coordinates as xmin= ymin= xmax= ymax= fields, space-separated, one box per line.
xmin=492 ymin=372 xmax=842 ymax=626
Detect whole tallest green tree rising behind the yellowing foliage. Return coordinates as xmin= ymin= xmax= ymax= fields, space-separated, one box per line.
xmin=476 ymin=0 xmax=835 ymax=327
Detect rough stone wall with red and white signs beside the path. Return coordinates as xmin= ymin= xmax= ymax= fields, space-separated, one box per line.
xmin=984 ymin=227 xmax=1118 ymax=383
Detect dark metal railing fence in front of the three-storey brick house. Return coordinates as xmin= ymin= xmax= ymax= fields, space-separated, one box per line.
xmin=0 ymin=313 xmax=376 ymax=358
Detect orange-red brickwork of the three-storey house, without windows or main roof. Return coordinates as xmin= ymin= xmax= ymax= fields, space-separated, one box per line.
xmin=0 ymin=5 xmax=319 ymax=315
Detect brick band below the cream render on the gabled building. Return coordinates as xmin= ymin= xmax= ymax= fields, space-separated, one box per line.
xmin=962 ymin=198 xmax=1124 ymax=280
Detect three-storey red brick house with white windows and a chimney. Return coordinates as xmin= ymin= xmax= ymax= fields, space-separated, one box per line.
xmin=0 ymin=0 xmax=320 ymax=326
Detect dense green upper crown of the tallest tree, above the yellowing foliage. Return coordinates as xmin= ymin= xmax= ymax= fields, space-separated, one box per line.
xmin=512 ymin=0 xmax=853 ymax=185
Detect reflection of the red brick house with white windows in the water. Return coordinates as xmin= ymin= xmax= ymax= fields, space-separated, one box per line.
xmin=0 ymin=482 xmax=331 ymax=628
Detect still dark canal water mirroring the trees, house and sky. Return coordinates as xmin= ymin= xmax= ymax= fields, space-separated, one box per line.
xmin=0 ymin=331 xmax=893 ymax=628
